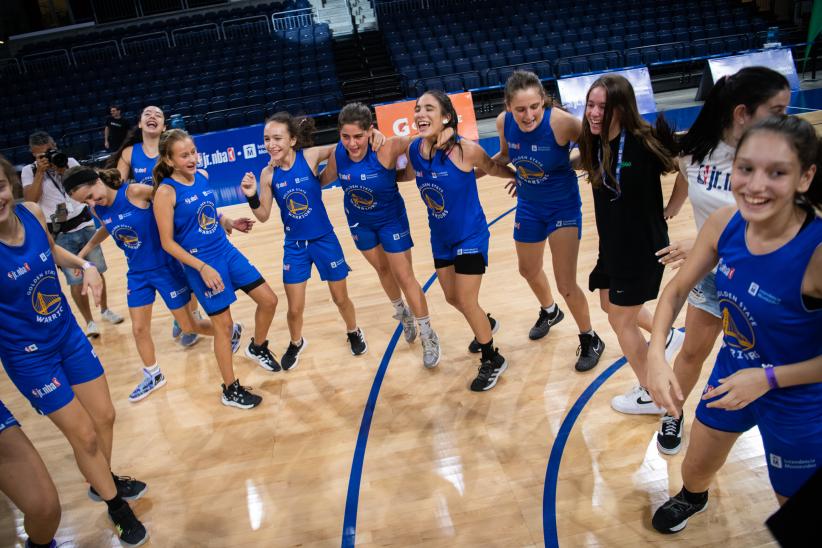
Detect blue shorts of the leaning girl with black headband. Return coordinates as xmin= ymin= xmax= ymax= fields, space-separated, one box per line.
xmin=126 ymin=260 xmax=191 ymax=310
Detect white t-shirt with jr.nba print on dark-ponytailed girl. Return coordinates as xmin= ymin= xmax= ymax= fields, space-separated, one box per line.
xmin=680 ymin=140 xmax=736 ymax=230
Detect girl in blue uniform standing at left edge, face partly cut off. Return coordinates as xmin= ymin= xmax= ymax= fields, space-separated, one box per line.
xmin=0 ymin=153 xmax=148 ymax=546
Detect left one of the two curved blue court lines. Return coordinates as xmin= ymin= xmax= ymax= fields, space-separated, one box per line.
xmin=341 ymin=207 xmax=516 ymax=548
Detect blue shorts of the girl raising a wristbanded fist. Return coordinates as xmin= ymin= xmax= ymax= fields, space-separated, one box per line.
xmin=283 ymin=230 xmax=349 ymax=284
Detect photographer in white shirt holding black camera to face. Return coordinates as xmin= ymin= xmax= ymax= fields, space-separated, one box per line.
xmin=21 ymin=131 xmax=123 ymax=338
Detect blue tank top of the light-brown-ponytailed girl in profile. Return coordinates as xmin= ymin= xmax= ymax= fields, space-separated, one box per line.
xmin=162 ymin=171 xmax=231 ymax=258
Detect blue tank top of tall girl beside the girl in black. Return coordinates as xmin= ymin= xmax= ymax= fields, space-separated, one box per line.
xmin=503 ymin=109 xmax=582 ymax=208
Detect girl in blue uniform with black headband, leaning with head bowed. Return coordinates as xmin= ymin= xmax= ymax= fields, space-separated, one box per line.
xmin=63 ymin=166 xmax=217 ymax=402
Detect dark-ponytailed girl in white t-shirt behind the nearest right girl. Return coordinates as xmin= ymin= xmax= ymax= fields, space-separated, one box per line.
xmin=648 ymin=67 xmax=791 ymax=455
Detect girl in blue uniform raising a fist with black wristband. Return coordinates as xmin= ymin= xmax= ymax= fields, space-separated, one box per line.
xmin=241 ymin=112 xmax=368 ymax=370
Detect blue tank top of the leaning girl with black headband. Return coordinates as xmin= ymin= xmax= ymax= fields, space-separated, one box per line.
xmin=94 ymin=185 xmax=171 ymax=272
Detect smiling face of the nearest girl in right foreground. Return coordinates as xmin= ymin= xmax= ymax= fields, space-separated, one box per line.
xmin=731 ymin=130 xmax=817 ymax=222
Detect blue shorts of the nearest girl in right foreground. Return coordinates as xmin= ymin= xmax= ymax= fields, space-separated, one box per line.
xmin=696 ymin=360 xmax=822 ymax=497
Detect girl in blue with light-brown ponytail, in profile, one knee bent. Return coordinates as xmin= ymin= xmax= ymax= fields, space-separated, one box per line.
xmin=154 ymin=129 xmax=280 ymax=409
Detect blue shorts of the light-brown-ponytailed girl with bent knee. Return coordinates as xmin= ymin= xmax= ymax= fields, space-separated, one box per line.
xmin=183 ymin=244 xmax=265 ymax=316
